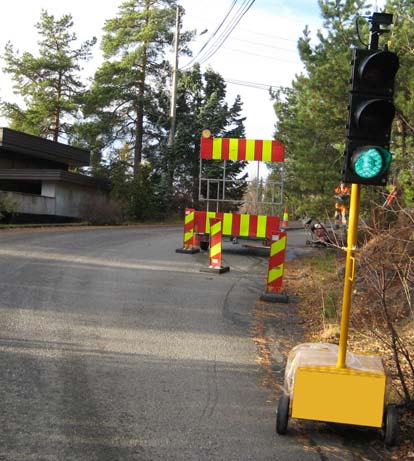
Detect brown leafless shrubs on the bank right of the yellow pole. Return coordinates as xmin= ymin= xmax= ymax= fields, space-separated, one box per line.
xmin=353 ymin=206 xmax=414 ymax=404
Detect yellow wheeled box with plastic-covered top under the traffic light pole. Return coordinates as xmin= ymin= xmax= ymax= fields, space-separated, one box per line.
xmin=285 ymin=343 xmax=387 ymax=428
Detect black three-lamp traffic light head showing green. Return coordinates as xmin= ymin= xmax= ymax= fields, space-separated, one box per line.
xmin=342 ymin=49 xmax=399 ymax=186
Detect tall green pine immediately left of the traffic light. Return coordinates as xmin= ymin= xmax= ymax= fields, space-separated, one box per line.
xmin=273 ymin=0 xmax=366 ymax=217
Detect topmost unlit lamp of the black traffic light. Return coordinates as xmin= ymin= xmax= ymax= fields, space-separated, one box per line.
xmin=359 ymin=51 xmax=399 ymax=87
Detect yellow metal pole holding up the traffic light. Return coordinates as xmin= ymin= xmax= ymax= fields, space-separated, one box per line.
xmin=336 ymin=184 xmax=361 ymax=368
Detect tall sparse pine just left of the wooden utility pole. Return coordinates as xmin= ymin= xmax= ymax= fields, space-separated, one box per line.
xmin=85 ymin=0 xmax=191 ymax=175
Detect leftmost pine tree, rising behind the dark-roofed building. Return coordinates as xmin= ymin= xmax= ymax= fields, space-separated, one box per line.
xmin=0 ymin=10 xmax=96 ymax=141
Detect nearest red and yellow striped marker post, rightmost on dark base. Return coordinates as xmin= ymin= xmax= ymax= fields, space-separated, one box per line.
xmin=260 ymin=232 xmax=289 ymax=303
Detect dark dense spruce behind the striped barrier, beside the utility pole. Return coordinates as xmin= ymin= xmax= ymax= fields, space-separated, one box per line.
xmin=166 ymin=65 xmax=246 ymax=209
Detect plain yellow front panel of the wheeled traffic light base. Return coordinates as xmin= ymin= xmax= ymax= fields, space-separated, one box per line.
xmin=292 ymin=366 xmax=386 ymax=427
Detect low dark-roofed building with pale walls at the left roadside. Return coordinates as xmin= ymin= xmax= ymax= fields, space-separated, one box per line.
xmin=0 ymin=128 xmax=110 ymax=218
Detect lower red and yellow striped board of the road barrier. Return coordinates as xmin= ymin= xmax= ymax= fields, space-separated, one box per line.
xmin=195 ymin=211 xmax=280 ymax=241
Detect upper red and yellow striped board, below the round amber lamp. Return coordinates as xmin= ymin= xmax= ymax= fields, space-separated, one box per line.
xmin=200 ymin=138 xmax=285 ymax=162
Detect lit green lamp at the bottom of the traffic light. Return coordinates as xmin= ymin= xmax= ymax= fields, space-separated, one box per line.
xmin=352 ymin=146 xmax=391 ymax=179
